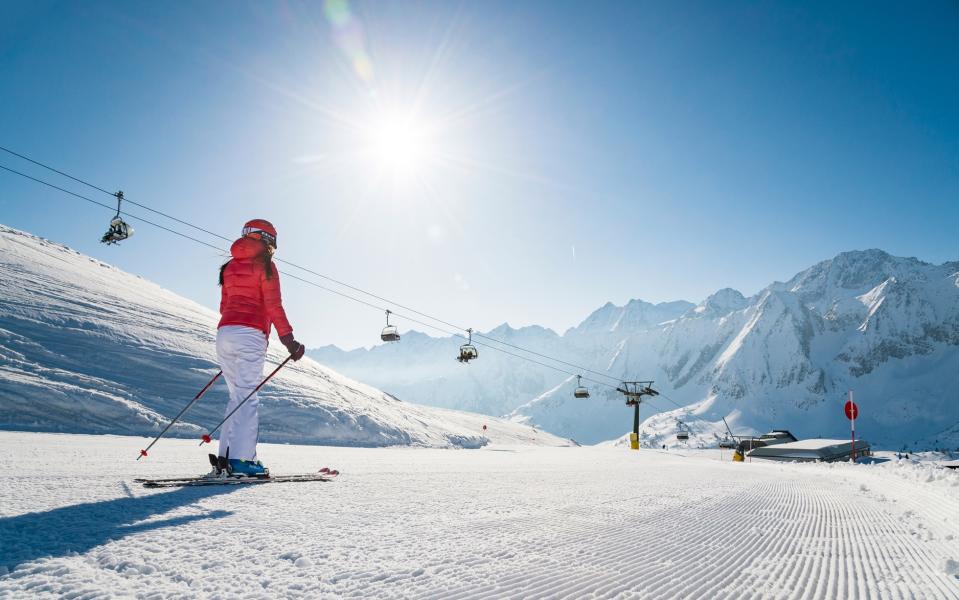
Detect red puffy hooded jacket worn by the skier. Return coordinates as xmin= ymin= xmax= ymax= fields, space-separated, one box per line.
xmin=217 ymin=237 xmax=293 ymax=337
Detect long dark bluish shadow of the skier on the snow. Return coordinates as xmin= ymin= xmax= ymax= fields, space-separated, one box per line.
xmin=0 ymin=485 xmax=237 ymax=575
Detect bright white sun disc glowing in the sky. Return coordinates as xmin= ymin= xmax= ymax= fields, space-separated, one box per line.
xmin=367 ymin=113 xmax=435 ymax=179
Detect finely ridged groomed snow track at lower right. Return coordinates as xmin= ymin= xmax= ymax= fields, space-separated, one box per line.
xmin=415 ymin=465 xmax=959 ymax=600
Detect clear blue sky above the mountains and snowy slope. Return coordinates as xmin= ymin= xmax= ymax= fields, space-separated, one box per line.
xmin=0 ymin=2 xmax=959 ymax=347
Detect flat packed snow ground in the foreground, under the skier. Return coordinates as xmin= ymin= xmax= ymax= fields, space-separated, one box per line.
xmin=0 ymin=432 xmax=959 ymax=600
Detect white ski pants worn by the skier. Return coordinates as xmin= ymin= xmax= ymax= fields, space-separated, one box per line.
xmin=216 ymin=325 xmax=267 ymax=460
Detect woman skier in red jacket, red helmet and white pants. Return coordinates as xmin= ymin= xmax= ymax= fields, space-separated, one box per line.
xmin=216 ymin=219 xmax=306 ymax=476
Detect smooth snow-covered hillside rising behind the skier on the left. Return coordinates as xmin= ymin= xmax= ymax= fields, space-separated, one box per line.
xmin=0 ymin=226 xmax=566 ymax=447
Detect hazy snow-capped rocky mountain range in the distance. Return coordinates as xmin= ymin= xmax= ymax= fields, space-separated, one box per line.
xmin=310 ymin=250 xmax=959 ymax=448
